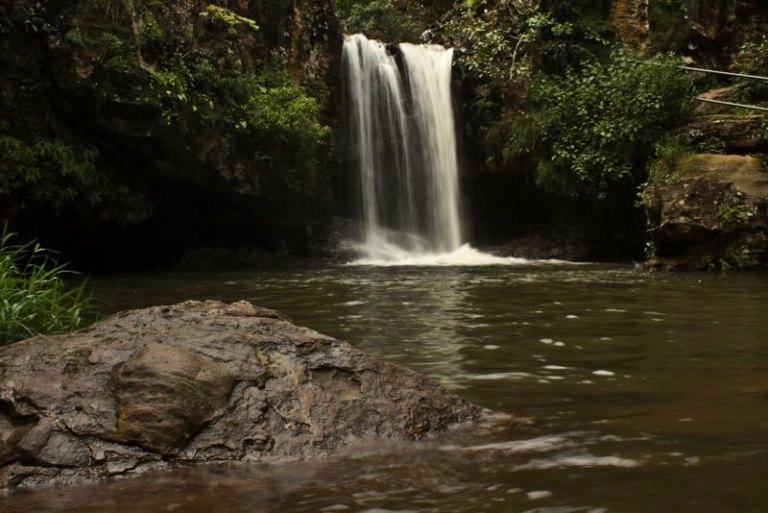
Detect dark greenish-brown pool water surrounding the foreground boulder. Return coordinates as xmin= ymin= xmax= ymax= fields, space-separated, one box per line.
xmin=0 ymin=265 xmax=768 ymax=513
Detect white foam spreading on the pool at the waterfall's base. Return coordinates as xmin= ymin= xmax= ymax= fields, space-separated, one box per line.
xmin=349 ymin=243 xmax=570 ymax=267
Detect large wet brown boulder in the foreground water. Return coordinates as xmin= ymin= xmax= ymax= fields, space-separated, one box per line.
xmin=0 ymin=301 xmax=480 ymax=489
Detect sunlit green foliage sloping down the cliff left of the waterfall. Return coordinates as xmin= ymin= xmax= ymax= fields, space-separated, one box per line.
xmin=64 ymin=0 xmax=330 ymax=194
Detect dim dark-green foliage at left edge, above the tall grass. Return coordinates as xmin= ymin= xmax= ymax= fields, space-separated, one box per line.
xmin=0 ymin=120 xmax=150 ymax=224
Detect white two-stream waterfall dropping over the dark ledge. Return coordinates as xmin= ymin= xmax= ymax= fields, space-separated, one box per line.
xmin=343 ymin=34 xmax=462 ymax=260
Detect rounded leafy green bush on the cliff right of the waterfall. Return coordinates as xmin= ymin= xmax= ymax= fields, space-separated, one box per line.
xmin=520 ymin=50 xmax=693 ymax=197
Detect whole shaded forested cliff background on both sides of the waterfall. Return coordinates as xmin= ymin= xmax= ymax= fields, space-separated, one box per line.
xmin=0 ymin=0 xmax=768 ymax=269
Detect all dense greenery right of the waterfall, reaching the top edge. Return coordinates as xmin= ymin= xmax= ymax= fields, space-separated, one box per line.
xmin=438 ymin=0 xmax=693 ymax=198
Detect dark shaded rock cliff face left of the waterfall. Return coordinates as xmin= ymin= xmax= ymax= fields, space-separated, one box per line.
xmin=0 ymin=0 xmax=342 ymax=270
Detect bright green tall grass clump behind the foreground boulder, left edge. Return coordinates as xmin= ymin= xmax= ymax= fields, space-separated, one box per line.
xmin=0 ymin=228 xmax=89 ymax=346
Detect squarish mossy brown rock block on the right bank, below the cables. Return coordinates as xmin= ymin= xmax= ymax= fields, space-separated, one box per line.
xmin=645 ymin=154 xmax=768 ymax=270
